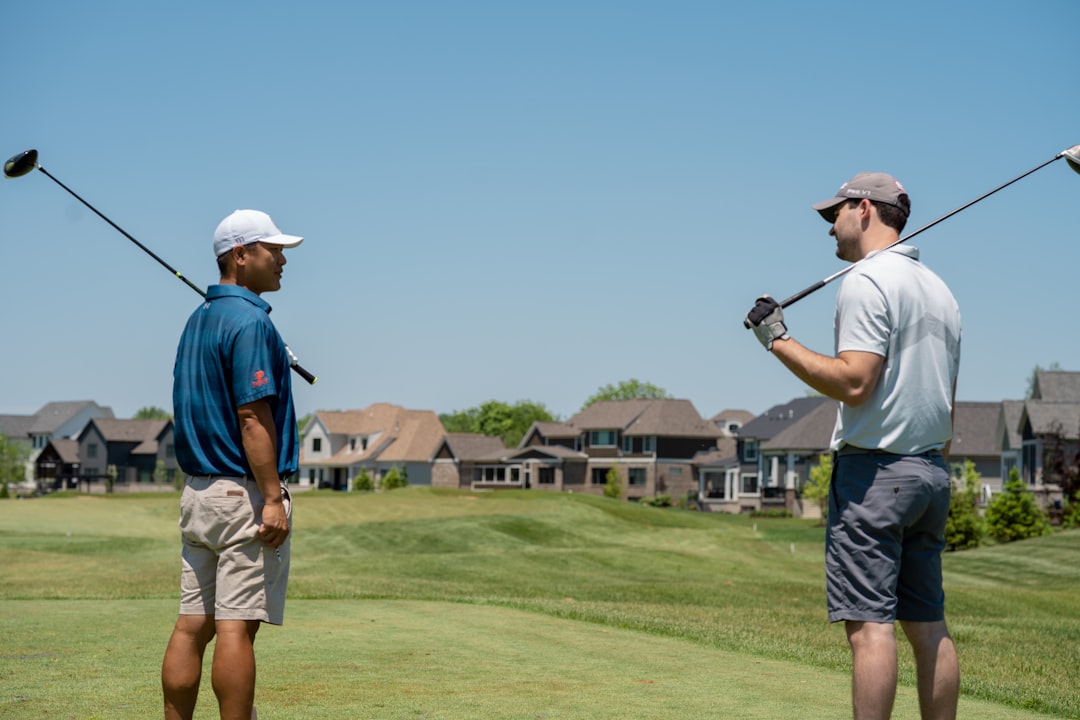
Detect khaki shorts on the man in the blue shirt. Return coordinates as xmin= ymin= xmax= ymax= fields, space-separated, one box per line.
xmin=180 ymin=476 xmax=293 ymax=625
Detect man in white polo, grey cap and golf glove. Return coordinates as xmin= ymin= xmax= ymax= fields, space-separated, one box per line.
xmin=746 ymin=173 xmax=960 ymax=720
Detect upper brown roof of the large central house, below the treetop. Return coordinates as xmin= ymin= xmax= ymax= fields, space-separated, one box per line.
xmin=565 ymin=399 xmax=721 ymax=438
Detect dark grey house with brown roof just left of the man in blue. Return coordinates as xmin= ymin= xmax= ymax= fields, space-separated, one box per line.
xmin=76 ymin=418 xmax=178 ymax=488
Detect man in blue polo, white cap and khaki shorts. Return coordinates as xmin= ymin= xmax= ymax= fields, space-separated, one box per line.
xmin=161 ymin=209 xmax=303 ymax=720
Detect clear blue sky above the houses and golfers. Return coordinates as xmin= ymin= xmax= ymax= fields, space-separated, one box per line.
xmin=0 ymin=0 xmax=1080 ymax=418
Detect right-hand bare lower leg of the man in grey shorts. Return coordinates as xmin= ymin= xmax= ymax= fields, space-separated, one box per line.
xmin=901 ymin=621 xmax=960 ymax=720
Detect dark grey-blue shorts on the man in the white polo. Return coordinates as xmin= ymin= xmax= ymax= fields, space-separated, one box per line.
xmin=825 ymin=452 xmax=950 ymax=623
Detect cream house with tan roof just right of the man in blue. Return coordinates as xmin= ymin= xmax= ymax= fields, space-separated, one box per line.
xmin=297 ymin=403 xmax=446 ymax=490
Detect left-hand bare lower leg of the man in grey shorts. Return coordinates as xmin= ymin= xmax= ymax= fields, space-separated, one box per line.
xmin=846 ymin=621 xmax=896 ymax=720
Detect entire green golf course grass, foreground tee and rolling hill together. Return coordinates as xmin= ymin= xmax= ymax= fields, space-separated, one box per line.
xmin=0 ymin=488 xmax=1080 ymax=720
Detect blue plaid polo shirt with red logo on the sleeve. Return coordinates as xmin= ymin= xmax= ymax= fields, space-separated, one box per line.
xmin=173 ymin=285 xmax=300 ymax=479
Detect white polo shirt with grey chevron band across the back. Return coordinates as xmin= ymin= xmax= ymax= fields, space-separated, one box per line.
xmin=832 ymin=245 xmax=960 ymax=454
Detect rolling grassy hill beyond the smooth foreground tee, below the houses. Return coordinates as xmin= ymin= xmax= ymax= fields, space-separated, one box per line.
xmin=0 ymin=488 xmax=1080 ymax=718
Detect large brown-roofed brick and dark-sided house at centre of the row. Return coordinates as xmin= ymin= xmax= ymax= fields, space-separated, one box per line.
xmin=442 ymin=399 xmax=725 ymax=500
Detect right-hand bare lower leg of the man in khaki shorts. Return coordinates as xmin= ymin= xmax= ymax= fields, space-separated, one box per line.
xmin=211 ymin=620 xmax=259 ymax=720
